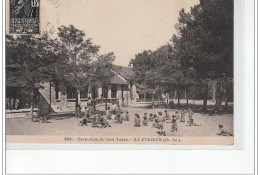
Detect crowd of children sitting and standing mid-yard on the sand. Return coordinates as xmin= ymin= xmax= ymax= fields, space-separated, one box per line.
xmin=80 ymin=102 xmax=202 ymax=135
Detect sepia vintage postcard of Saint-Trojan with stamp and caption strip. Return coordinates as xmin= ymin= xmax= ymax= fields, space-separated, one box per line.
xmin=5 ymin=0 xmax=236 ymax=145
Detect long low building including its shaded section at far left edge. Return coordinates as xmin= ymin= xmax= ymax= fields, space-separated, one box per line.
xmin=6 ymin=65 xmax=139 ymax=112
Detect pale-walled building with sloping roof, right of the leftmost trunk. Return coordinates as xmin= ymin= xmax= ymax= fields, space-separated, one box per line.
xmin=39 ymin=65 xmax=138 ymax=112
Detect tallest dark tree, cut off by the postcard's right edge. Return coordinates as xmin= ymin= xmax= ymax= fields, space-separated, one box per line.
xmin=172 ymin=0 xmax=233 ymax=110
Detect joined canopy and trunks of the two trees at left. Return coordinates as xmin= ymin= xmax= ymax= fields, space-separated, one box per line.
xmin=6 ymin=25 xmax=115 ymax=117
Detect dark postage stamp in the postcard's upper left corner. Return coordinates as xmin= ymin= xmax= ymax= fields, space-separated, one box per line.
xmin=9 ymin=0 xmax=40 ymax=34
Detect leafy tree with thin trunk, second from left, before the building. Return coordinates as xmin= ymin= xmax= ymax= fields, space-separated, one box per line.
xmin=57 ymin=25 xmax=115 ymax=114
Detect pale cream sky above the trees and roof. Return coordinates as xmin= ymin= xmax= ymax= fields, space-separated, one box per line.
xmin=40 ymin=0 xmax=199 ymax=66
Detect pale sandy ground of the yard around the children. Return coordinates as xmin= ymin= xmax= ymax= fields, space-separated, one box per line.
xmin=6 ymin=108 xmax=233 ymax=136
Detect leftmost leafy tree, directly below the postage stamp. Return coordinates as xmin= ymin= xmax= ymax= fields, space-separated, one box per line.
xmin=6 ymin=33 xmax=62 ymax=117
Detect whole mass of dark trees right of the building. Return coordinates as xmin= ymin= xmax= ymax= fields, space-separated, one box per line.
xmin=130 ymin=0 xmax=233 ymax=109
